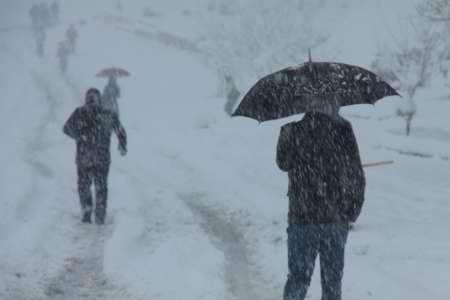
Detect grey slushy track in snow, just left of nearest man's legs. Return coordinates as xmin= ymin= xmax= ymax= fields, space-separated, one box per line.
xmin=179 ymin=193 xmax=261 ymax=300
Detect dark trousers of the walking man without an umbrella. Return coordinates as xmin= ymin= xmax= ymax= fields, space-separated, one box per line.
xmin=78 ymin=164 xmax=109 ymax=220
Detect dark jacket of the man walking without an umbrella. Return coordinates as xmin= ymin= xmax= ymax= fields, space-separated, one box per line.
xmin=63 ymin=104 xmax=127 ymax=166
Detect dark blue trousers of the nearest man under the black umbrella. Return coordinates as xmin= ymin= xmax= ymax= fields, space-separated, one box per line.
xmin=283 ymin=224 xmax=349 ymax=300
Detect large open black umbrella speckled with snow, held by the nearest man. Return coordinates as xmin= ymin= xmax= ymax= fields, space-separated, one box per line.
xmin=232 ymin=53 xmax=399 ymax=122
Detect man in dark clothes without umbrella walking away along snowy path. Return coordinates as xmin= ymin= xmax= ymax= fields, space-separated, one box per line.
xmin=63 ymin=88 xmax=127 ymax=224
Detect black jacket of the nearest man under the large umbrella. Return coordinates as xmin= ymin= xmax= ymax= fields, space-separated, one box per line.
xmin=277 ymin=113 xmax=365 ymax=224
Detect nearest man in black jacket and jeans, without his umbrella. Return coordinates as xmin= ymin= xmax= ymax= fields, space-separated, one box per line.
xmin=277 ymin=99 xmax=365 ymax=300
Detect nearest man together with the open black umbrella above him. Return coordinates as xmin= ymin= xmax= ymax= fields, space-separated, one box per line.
xmin=233 ymin=54 xmax=399 ymax=300
